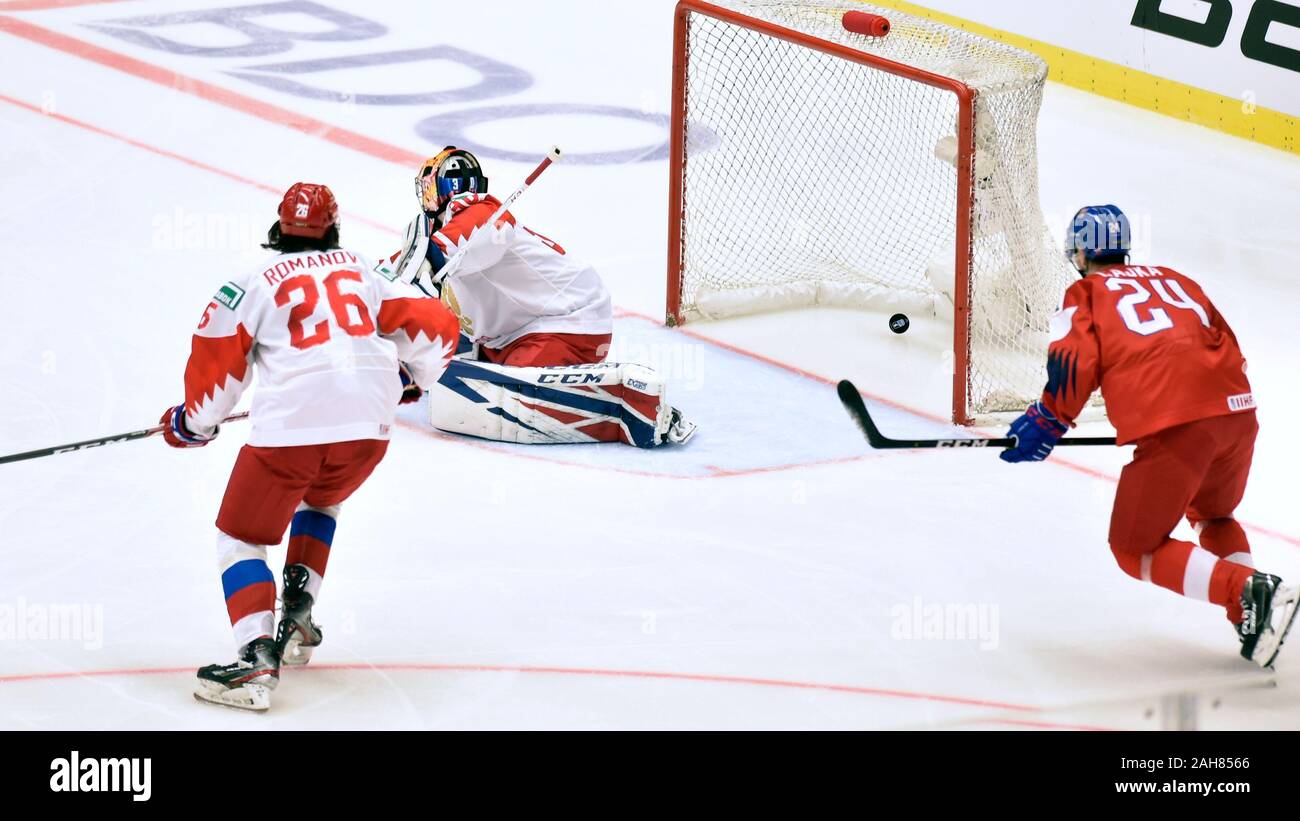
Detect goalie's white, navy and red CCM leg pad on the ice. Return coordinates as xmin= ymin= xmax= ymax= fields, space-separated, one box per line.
xmin=429 ymin=360 xmax=673 ymax=448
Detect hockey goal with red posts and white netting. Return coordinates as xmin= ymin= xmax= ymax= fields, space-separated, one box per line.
xmin=668 ymin=0 xmax=1076 ymax=423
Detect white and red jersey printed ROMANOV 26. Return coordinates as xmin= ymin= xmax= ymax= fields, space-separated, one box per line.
xmin=185 ymin=248 xmax=458 ymax=447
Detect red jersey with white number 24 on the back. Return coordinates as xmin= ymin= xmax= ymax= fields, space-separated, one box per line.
xmin=1043 ymin=265 xmax=1255 ymax=444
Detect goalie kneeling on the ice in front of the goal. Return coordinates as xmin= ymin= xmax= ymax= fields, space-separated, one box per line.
xmin=376 ymin=147 xmax=696 ymax=448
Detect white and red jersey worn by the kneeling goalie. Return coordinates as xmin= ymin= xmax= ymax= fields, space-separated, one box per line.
xmin=385 ymin=194 xmax=614 ymax=349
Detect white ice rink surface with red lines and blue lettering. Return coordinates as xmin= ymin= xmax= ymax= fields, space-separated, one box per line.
xmin=0 ymin=0 xmax=1300 ymax=729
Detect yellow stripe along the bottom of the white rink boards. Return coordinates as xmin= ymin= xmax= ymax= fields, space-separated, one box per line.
xmin=868 ymin=0 xmax=1300 ymax=155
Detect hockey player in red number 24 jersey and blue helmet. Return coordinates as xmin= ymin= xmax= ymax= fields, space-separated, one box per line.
xmin=1002 ymin=205 xmax=1297 ymax=666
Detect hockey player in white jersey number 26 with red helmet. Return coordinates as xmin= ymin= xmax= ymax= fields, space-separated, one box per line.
xmin=163 ymin=183 xmax=458 ymax=709
